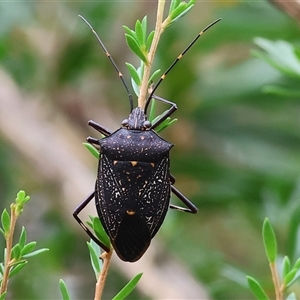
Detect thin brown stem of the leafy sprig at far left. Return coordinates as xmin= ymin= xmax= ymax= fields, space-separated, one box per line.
xmin=0 ymin=205 xmax=17 ymax=295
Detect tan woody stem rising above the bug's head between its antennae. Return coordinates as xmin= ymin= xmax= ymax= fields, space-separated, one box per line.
xmin=138 ymin=0 xmax=165 ymax=108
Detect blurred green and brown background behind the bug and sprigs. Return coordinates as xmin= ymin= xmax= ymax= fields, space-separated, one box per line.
xmin=0 ymin=1 xmax=300 ymax=299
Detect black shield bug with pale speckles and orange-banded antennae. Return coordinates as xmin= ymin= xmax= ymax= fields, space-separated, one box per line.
xmin=73 ymin=16 xmax=220 ymax=262
